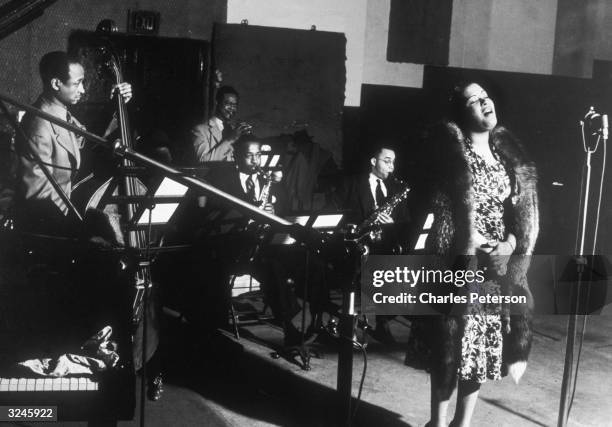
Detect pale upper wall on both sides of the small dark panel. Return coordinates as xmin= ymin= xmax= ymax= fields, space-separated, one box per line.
xmin=227 ymin=0 xmax=564 ymax=106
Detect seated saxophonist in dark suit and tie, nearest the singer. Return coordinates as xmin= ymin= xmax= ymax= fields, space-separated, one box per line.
xmin=342 ymin=141 xmax=410 ymax=344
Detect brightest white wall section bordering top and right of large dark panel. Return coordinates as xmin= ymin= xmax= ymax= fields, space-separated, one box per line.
xmin=227 ymin=0 xmax=367 ymax=106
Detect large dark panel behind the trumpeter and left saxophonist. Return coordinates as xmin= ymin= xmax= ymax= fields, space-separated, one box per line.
xmin=213 ymin=24 xmax=346 ymax=166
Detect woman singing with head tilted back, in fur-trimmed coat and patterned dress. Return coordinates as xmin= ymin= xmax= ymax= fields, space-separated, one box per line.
xmin=423 ymin=83 xmax=538 ymax=427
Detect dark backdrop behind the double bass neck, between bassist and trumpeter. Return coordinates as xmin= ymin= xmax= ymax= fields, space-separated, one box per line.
xmin=69 ymin=32 xmax=210 ymax=164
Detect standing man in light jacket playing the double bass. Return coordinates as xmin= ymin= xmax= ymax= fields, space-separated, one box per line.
xmin=17 ymin=51 xmax=132 ymax=234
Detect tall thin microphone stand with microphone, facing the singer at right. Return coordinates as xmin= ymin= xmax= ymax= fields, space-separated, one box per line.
xmin=557 ymin=111 xmax=608 ymax=427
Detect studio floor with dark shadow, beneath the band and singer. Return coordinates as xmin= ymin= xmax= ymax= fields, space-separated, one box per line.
xmin=2 ymin=307 xmax=612 ymax=427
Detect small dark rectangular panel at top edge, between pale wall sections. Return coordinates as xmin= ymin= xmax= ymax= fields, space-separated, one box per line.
xmin=387 ymin=0 xmax=453 ymax=65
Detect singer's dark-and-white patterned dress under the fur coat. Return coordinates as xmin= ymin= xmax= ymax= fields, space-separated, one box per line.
xmin=459 ymin=139 xmax=511 ymax=383
